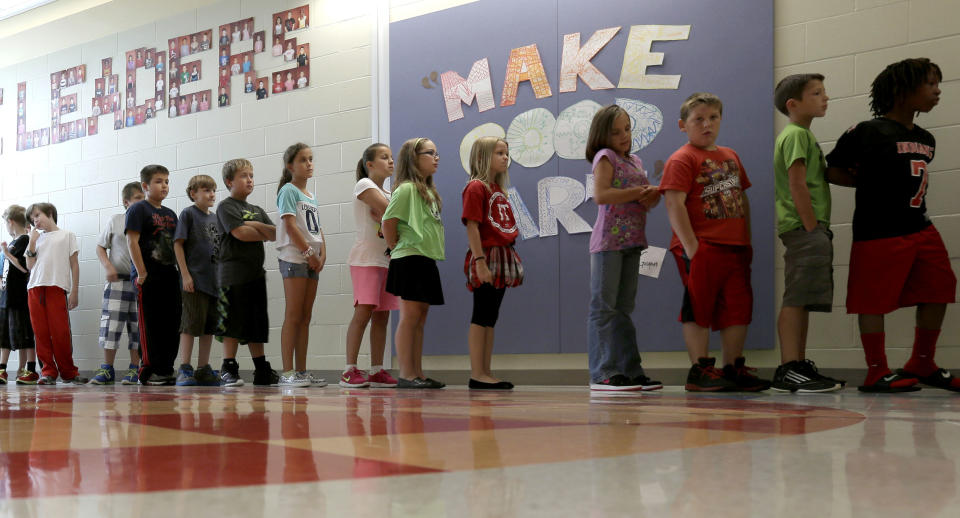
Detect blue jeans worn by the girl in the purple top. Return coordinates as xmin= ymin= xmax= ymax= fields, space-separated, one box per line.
xmin=587 ymin=247 xmax=644 ymax=383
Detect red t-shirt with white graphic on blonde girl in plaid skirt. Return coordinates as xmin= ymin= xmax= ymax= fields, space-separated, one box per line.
xmin=461 ymin=180 xmax=519 ymax=248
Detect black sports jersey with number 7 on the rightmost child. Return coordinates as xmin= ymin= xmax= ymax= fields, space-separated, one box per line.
xmin=827 ymin=117 xmax=936 ymax=241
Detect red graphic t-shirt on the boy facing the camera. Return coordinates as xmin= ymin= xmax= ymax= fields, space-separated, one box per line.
xmin=660 ymin=143 xmax=750 ymax=248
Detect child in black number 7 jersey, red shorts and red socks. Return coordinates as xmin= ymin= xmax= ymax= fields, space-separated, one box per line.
xmin=827 ymin=58 xmax=960 ymax=392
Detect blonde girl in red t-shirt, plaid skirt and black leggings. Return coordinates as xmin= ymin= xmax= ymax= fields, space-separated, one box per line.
xmin=460 ymin=137 xmax=523 ymax=390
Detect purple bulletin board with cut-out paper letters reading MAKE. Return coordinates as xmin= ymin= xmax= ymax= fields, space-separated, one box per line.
xmin=390 ymin=0 xmax=775 ymax=354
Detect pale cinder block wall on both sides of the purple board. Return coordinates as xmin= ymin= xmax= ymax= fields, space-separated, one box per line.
xmin=0 ymin=0 xmax=960 ymax=370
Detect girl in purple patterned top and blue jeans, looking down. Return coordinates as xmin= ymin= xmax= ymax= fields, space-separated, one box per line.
xmin=586 ymin=108 xmax=663 ymax=391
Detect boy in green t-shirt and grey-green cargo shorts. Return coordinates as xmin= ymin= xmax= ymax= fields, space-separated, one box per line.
xmin=772 ymin=74 xmax=843 ymax=393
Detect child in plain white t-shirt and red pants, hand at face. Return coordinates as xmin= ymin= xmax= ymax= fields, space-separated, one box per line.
xmin=24 ymin=203 xmax=87 ymax=385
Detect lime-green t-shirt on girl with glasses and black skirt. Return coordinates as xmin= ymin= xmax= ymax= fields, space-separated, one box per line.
xmin=383 ymin=182 xmax=445 ymax=261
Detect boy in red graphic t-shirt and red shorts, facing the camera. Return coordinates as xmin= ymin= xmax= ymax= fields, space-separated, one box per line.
xmin=660 ymin=93 xmax=770 ymax=392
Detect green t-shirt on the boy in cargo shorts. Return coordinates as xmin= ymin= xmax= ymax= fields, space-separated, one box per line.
xmin=773 ymin=122 xmax=830 ymax=234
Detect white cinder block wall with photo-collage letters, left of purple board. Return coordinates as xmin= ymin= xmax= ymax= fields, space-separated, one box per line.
xmin=0 ymin=0 xmax=375 ymax=370
